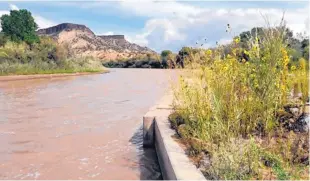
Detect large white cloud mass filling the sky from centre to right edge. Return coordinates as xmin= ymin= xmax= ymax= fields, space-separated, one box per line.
xmin=26 ymin=0 xmax=309 ymax=51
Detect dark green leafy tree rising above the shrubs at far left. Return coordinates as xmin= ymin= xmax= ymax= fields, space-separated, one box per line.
xmin=0 ymin=9 xmax=39 ymax=44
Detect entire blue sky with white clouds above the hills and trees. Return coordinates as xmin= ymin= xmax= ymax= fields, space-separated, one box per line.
xmin=0 ymin=0 xmax=309 ymax=52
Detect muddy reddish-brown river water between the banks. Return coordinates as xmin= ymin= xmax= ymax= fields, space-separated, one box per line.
xmin=0 ymin=69 xmax=176 ymax=180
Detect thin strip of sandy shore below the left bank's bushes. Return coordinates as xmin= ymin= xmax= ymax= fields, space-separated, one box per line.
xmin=0 ymin=71 xmax=109 ymax=82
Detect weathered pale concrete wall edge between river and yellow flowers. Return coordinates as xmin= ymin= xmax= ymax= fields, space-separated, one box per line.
xmin=143 ymin=93 xmax=206 ymax=180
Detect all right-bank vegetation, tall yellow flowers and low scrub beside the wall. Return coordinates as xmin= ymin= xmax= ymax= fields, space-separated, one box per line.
xmin=170 ymin=20 xmax=309 ymax=180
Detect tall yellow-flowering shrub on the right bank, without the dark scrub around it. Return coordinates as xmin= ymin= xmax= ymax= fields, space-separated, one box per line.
xmin=175 ymin=25 xmax=309 ymax=179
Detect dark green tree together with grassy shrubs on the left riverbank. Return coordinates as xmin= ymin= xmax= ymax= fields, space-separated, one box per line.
xmin=0 ymin=10 xmax=104 ymax=75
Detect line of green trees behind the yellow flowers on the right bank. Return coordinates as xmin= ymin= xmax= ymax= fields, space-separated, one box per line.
xmin=161 ymin=27 xmax=309 ymax=68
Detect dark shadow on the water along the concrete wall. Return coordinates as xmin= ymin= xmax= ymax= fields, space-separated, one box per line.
xmin=129 ymin=126 xmax=163 ymax=180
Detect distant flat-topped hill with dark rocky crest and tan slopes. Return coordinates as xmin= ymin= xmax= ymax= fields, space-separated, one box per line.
xmin=37 ymin=23 xmax=156 ymax=60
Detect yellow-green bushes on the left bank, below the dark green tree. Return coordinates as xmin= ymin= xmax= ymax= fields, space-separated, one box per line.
xmin=0 ymin=37 xmax=103 ymax=75
